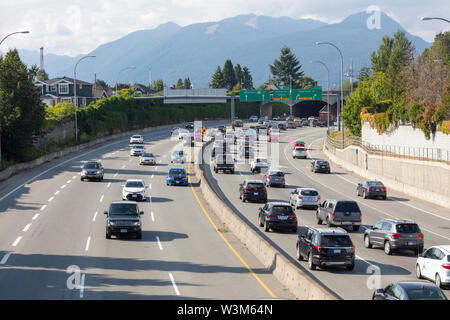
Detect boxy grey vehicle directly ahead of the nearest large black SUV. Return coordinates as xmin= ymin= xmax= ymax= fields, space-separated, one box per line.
xmin=316 ymin=199 xmax=362 ymax=231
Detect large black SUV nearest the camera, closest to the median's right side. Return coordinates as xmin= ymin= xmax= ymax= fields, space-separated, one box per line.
xmin=296 ymin=227 xmax=355 ymax=270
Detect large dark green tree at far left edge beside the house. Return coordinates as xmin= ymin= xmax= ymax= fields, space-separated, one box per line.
xmin=0 ymin=50 xmax=45 ymax=160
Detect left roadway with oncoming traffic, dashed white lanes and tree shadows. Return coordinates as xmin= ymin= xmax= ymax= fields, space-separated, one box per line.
xmin=0 ymin=122 xmax=293 ymax=300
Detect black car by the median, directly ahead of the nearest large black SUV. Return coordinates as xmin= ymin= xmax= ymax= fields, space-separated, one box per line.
xmin=258 ymin=202 xmax=298 ymax=232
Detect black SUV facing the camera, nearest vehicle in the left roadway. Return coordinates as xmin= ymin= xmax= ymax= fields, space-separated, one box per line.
xmin=104 ymin=201 xmax=144 ymax=239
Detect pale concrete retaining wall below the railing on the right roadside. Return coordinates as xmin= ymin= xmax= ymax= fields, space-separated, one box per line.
xmin=324 ymin=143 xmax=450 ymax=208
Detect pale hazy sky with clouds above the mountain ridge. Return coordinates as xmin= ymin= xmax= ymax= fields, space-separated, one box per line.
xmin=0 ymin=0 xmax=450 ymax=56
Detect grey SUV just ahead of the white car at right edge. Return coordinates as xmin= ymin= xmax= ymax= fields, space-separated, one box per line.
xmin=364 ymin=219 xmax=424 ymax=255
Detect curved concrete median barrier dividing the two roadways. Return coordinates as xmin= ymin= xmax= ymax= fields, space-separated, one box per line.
xmin=193 ymin=140 xmax=337 ymax=300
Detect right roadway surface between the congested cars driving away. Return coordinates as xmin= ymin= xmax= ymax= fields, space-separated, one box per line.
xmin=204 ymin=127 xmax=450 ymax=299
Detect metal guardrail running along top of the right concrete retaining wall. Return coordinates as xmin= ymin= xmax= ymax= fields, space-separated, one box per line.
xmin=326 ymin=129 xmax=450 ymax=164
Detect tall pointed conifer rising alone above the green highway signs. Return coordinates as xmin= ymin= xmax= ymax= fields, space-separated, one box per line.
xmin=270 ymin=46 xmax=304 ymax=86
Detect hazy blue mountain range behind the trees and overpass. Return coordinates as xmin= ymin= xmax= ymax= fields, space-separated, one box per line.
xmin=3 ymin=12 xmax=431 ymax=88
